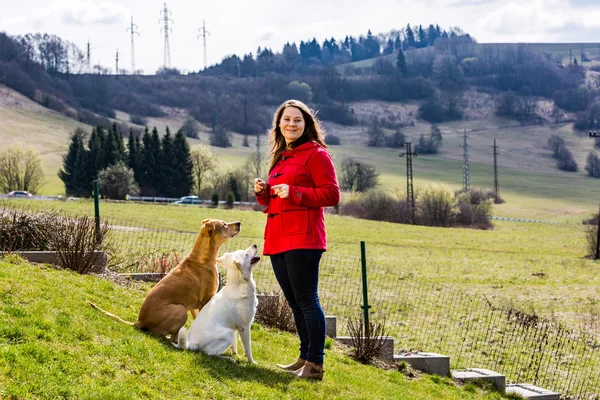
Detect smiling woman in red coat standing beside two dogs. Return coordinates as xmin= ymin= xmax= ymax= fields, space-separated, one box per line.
xmin=254 ymin=100 xmax=340 ymax=380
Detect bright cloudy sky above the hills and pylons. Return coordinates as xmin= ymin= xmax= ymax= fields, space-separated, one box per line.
xmin=0 ymin=0 xmax=600 ymax=74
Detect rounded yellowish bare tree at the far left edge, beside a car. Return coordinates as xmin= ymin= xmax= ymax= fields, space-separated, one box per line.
xmin=0 ymin=147 xmax=44 ymax=193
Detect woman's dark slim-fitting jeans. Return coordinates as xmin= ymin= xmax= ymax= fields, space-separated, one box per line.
xmin=271 ymin=250 xmax=325 ymax=365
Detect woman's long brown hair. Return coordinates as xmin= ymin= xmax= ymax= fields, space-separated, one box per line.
xmin=269 ymin=100 xmax=327 ymax=172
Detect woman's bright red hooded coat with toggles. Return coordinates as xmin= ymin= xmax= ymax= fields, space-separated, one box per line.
xmin=256 ymin=142 xmax=340 ymax=255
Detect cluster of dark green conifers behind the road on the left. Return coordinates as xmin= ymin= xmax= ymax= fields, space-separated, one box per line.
xmin=58 ymin=125 xmax=194 ymax=197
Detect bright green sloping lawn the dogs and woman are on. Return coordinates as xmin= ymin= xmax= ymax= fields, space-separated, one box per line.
xmin=0 ymin=257 xmax=510 ymax=399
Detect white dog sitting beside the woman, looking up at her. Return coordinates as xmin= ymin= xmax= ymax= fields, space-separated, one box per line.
xmin=177 ymin=245 xmax=260 ymax=364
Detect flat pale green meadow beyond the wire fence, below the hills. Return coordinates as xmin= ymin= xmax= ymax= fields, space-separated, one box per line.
xmin=11 ymin=201 xmax=600 ymax=340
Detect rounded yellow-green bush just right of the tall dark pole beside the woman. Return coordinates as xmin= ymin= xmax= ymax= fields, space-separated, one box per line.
xmin=417 ymin=185 xmax=458 ymax=226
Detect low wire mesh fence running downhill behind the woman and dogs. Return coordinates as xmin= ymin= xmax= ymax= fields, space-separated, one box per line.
xmin=0 ymin=202 xmax=600 ymax=400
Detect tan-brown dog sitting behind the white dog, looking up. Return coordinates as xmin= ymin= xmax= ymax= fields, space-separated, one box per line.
xmin=89 ymin=219 xmax=241 ymax=343
